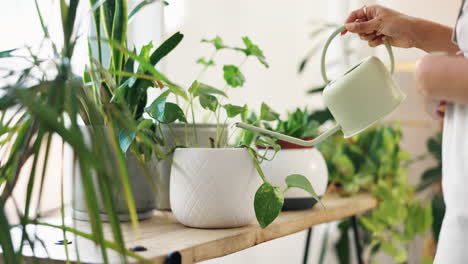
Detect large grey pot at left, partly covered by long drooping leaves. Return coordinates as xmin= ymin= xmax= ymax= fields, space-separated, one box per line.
xmin=69 ymin=127 xmax=158 ymax=221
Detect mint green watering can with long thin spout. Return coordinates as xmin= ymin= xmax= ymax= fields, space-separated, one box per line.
xmin=236 ymin=26 xmax=406 ymax=146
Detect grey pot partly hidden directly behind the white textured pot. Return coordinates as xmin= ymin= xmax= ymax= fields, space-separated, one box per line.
xmin=156 ymin=124 xmax=228 ymax=210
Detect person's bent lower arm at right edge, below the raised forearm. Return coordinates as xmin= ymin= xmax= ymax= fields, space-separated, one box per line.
xmin=416 ymin=55 xmax=468 ymax=104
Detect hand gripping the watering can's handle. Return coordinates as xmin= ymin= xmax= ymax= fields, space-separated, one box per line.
xmin=342 ymin=5 xmax=414 ymax=48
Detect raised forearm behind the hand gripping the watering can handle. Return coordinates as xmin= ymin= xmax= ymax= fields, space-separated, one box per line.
xmin=408 ymin=17 xmax=459 ymax=55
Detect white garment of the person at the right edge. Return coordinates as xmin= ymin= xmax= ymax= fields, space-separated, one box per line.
xmin=434 ymin=1 xmax=468 ymax=264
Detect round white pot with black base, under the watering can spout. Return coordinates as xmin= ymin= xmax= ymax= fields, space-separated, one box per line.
xmin=259 ymin=142 xmax=328 ymax=210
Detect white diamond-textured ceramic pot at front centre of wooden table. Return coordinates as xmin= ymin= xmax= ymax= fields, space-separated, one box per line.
xmin=170 ymin=148 xmax=262 ymax=228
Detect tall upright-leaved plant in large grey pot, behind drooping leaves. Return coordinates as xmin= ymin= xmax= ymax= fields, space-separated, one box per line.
xmin=71 ymin=1 xmax=183 ymax=220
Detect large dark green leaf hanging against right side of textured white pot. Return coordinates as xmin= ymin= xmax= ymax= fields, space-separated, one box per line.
xmin=254 ymin=183 xmax=284 ymax=228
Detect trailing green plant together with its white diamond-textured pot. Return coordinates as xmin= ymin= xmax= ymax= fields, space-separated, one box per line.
xmin=165 ymin=37 xmax=322 ymax=228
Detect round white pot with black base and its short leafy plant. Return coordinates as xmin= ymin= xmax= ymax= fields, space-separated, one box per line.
xmin=249 ymin=104 xmax=328 ymax=210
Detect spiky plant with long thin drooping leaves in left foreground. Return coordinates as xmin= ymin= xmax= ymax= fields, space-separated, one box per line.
xmin=0 ymin=0 xmax=159 ymax=263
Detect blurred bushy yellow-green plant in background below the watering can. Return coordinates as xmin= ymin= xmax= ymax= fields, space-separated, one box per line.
xmin=319 ymin=123 xmax=432 ymax=263
